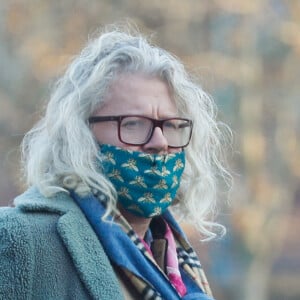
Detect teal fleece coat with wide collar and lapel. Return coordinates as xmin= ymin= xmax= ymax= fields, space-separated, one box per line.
xmin=0 ymin=188 xmax=123 ymax=300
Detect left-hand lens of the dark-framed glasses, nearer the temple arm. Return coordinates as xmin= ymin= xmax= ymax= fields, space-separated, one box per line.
xmin=120 ymin=116 xmax=152 ymax=145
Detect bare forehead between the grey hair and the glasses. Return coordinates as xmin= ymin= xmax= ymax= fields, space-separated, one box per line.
xmin=99 ymin=74 xmax=177 ymax=117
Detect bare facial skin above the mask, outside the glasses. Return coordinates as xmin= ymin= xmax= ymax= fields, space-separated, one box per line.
xmin=92 ymin=74 xmax=181 ymax=154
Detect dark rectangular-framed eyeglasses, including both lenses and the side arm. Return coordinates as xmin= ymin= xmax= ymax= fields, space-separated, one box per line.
xmin=89 ymin=115 xmax=193 ymax=148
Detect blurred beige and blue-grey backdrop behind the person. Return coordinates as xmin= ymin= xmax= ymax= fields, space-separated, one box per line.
xmin=0 ymin=0 xmax=300 ymax=300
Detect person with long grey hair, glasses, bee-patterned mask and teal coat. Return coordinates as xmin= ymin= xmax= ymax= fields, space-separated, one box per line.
xmin=0 ymin=24 xmax=231 ymax=299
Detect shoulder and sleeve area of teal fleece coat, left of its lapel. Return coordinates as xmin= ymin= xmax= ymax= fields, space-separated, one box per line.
xmin=0 ymin=196 xmax=88 ymax=300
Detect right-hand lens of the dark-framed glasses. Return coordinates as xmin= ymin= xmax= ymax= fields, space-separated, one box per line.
xmin=163 ymin=118 xmax=192 ymax=147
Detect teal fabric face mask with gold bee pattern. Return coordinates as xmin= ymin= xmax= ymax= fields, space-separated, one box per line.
xmin=100 ymin=144 xmax=185 ymax=218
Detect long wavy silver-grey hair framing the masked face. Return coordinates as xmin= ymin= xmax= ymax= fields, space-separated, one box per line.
xmin=22 ymin=28 xmax=230 ymax=238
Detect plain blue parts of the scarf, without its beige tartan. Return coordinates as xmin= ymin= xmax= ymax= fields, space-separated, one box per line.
xmin=71 ymin=192 xmax=212 ymax=300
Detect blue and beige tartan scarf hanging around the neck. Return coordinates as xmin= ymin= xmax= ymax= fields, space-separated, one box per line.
xmin=71 ymin=191 xmax=213 ymax=300
